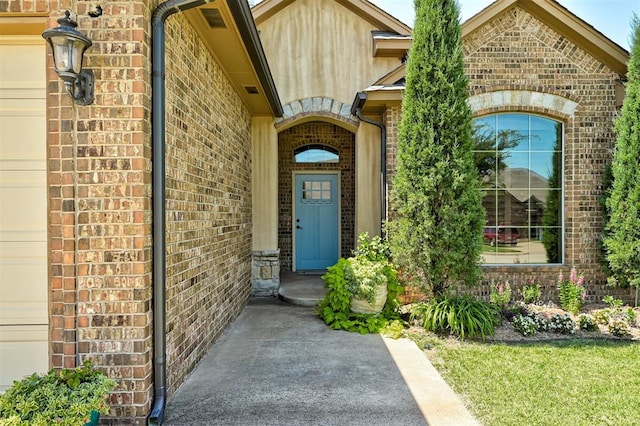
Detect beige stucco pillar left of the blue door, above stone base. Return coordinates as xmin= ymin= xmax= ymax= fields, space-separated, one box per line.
xmin=251 ymin=117 xmax=278 ymax=251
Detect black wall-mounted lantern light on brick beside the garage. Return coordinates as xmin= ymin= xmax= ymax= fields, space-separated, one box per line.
xmin=42 ymin=10 xmax=93 ymax=105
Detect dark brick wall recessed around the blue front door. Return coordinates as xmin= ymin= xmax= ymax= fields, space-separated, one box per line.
xmin=278 ymin=122 xmax=355 ymax=271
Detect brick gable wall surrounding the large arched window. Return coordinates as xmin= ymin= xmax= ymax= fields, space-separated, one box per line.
xmin=387 ymin=7 xmax=631 ymax=301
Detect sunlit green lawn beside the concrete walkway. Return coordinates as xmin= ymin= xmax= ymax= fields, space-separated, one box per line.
xmin=429 ymin=339 xmax=640 ymax=426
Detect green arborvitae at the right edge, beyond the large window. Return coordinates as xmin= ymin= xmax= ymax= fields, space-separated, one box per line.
xmin=604 ymin=17 xmax=640 ymax=287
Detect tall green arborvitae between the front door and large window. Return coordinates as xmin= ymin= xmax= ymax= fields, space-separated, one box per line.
xmin=388 ymin=0 xmax=485 ymax=296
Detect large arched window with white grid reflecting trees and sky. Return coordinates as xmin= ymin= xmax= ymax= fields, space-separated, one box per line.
xmin=473 ymin=113 xmax=563 ymax=264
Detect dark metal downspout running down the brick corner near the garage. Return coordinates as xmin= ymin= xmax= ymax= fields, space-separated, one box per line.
xmin=147 ymin=0 xmax=209 ymax=425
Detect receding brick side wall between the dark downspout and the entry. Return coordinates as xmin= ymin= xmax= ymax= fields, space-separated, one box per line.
xmin=167 ymin=15 xmax=251 ymax=394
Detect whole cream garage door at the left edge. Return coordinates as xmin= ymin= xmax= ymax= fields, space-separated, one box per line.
xmin=0 ymin=36 xmax=49 ymax=392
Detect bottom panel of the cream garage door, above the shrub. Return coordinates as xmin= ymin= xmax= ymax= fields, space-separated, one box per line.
xmin=0 ymin=325 xmax=49 ymax=392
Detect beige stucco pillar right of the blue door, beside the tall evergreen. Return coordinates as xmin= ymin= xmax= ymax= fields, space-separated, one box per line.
xmin=356 ymin=122 xmax=380 ymax=236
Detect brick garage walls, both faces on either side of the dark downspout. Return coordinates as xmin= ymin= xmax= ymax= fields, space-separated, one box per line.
xmin=35 ymin=1 xmax=251 ymax=424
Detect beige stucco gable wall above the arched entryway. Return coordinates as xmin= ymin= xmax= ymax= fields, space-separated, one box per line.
xmin=258 ymin=0 xmax=401 ymax=105
